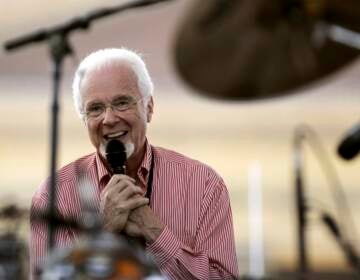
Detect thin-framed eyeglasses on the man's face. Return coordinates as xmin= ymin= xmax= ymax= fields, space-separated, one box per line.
xmin=83 ymin=96 xmax=144 ymax=118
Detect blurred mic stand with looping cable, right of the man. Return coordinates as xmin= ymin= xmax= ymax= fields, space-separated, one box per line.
xmin=293 ymin=125 xmax=360 ymax=279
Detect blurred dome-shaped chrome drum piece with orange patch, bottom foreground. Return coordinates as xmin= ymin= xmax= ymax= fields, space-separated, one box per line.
xmin=41 ymin=232 xmax=148 ymax=280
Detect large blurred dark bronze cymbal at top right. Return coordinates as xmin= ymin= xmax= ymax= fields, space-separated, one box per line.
xmin=175 ymin=0 xmax=360 ymax=100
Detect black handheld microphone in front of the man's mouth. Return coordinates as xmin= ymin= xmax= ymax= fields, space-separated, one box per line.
xmin=105 ymin=139 xmax=127 ymax=174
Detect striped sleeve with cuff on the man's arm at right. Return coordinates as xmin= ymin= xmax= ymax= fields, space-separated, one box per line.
xmin=148 ymin=174 xmax=239 ymax=280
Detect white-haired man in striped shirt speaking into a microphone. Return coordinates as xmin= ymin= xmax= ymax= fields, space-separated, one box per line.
xmin=30 ymin=49 xmax=238 ymax=279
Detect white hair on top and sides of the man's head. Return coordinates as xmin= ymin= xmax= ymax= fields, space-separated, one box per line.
xmin=72 ymin=48 xmax=154 ymax=117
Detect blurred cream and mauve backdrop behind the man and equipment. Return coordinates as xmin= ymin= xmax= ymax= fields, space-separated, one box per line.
xmin=0 ymin=0 xmax=360 ymax=275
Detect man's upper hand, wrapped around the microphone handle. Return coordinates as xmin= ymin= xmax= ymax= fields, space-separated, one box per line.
xmin=100 ymin=174 xmax=149 ymax=233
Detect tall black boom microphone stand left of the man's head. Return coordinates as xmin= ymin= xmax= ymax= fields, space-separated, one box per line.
xmin=4 ymin=0 xmax=171 ymax=249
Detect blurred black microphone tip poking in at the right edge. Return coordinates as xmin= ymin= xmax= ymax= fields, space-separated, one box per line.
xmin=337 ymin=124 xmax=360 ymax=160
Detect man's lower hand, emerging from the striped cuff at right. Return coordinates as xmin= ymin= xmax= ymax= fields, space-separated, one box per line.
xmin=124 ymin=205 xmax=165 ymax=243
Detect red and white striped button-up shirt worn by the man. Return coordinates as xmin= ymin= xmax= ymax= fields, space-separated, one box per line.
xmin=30 ymin=143 xmax=239 ymax=280
